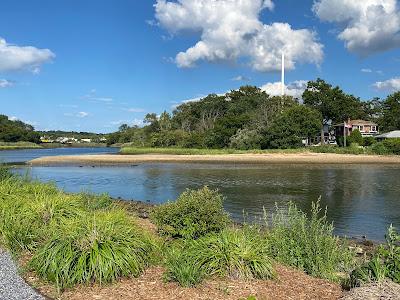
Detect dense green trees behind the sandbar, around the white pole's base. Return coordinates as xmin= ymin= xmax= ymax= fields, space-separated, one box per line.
xmin=108 ymin=79 xmax=400 ymax=150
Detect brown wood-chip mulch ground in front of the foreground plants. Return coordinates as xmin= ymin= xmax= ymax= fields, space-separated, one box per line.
xmin=28 ymin=266 xmax=343 ymax=300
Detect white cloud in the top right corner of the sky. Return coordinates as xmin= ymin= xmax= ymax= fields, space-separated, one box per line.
xmin=313 ymin=0 xmax=400 ymax=56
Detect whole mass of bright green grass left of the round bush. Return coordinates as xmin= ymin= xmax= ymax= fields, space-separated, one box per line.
xmin=0 ymin=168 xmax=156 ymax=290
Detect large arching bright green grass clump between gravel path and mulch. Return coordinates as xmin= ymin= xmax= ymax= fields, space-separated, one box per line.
xmin=30 ymin=210 xmax=153 ymax=289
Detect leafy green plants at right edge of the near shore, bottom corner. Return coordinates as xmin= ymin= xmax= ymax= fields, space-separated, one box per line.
xmin=351 ymin=225 xmax=400 ymax=286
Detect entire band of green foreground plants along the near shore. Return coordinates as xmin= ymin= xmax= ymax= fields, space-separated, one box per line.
xmin=0 ymin=166 xmax=400 ymax=292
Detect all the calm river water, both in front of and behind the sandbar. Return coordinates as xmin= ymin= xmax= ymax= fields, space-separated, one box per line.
xmin=0 ymin=148 xmax=400 ymax=241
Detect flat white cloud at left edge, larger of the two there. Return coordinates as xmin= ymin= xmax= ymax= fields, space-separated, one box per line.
xmin=0 ymin=38 xmax=55 ymax=74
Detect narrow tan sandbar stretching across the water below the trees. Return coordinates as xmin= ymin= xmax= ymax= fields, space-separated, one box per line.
xmin=29 ymin=153 xmax=400 ymax=166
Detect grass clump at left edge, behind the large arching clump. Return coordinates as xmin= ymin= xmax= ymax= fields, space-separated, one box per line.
xmin=0 ymin=175 xmax=84 ymax=254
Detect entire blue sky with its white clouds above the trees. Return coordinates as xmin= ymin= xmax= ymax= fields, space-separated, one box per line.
xmin=0 ymin=0 xmax=400 ymax=132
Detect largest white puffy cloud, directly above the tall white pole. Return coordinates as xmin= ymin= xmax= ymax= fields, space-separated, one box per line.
xmin=155 ymin=0 xmax=323 ymax=72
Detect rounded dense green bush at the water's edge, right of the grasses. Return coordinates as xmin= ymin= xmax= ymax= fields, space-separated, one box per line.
xmin=151 ymin=187 xmax=229 ymax=238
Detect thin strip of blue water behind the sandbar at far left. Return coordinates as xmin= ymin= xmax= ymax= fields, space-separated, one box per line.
xmin=0 ymin=147 xmax=119 ymax=163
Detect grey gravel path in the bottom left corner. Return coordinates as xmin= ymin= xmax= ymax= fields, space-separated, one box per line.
xmin=0 ymin=249 xmax=44 ymax=300
